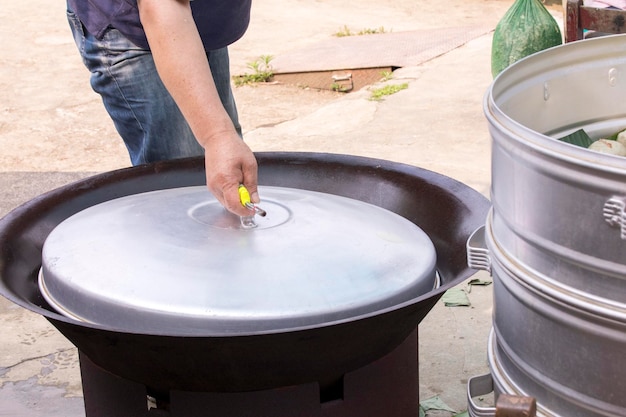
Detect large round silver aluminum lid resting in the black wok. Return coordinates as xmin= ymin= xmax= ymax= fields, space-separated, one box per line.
xmin=39 ymin=186 xmax=436 ymax=335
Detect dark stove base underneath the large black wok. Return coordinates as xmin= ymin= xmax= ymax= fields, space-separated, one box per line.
xmin=80 ymin=329 xmax=419 ymax=417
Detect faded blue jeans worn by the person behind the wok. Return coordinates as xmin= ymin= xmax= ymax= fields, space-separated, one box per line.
xmin=67 ymin=10 xmax=241 ymax=165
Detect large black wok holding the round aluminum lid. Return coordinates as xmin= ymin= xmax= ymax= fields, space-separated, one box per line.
xmin=0 ymin=153 xmax=490 ymax=392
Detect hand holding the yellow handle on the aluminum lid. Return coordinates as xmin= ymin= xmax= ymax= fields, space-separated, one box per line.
xmin=204 ymin=131 xmax=260 ymax=216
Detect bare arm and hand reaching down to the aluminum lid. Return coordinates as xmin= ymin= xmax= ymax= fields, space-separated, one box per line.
xmin=137 ymin=0 xmax=259 ymax=216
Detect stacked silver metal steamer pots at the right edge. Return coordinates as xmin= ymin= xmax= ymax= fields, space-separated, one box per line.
xmin=468 ymin=35 xmax=626 ymax=417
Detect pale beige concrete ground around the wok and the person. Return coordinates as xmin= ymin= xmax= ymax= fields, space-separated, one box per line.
xmin=0 ymin=0 xmax=562 ymax=417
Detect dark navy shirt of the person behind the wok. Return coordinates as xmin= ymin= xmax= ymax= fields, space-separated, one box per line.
xmin=67 ymin=0 xmax=252 ymax=50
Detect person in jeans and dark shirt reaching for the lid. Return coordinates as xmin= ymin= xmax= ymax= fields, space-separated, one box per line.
xmin=67 ymin=0 xmax=259 ymax=216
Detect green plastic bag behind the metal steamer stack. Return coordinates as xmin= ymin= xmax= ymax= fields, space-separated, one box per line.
xmin=491 ymin=0 xmax=563 ymax=78
